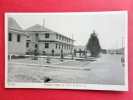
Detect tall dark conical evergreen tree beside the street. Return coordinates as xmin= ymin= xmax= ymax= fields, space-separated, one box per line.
xmin=86 ymin=31 xmax=101 ymax=57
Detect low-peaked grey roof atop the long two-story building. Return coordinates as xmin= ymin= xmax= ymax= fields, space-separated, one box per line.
xmin=25 ymin=24 xmax=55 ymax=33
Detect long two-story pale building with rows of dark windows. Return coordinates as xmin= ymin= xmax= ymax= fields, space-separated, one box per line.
xmin=25 ymin=24 xmax=74 ymax=54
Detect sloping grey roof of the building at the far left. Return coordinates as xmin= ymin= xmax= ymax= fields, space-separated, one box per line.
xmin=8 ymin=17 xmax=23 ymax=31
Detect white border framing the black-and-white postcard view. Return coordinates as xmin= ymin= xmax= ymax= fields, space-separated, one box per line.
xmin=5 ymin=11 xmax=128 ymax=91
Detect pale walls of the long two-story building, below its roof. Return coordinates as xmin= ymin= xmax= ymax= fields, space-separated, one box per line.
xmin=26 ymin=32 xmax=72 ymax=54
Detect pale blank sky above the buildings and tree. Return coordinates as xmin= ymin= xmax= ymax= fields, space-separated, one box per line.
xmin=8 ymin=13 xmax=126 ymax=49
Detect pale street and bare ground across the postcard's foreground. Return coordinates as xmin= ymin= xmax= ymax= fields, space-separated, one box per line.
xmin=9 ymin=54 xmax=125 ymax=85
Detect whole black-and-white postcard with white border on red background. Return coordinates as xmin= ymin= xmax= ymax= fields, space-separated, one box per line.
xmin=5 ymin=11 xmax=128 ymax=91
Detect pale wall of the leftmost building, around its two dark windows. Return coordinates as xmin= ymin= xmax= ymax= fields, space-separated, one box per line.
xmin=8 ymin=30 xmax=26 ymax=55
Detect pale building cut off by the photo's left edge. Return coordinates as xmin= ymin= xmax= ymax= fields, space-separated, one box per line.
xmin=8 ymin=17 xmax=26 ymax=55
